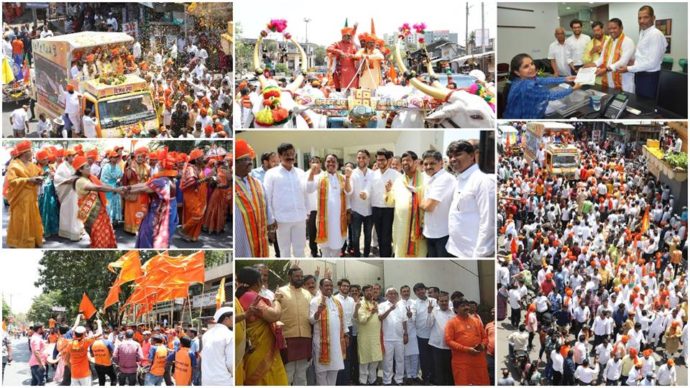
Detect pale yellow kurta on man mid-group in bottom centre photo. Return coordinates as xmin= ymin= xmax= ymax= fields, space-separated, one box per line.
xmin=357 ymin=300 xmax=383 ymax=364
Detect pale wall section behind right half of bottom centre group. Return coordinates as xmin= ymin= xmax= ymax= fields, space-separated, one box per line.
xmin=383 ymin=260 xmax=479 ymax=302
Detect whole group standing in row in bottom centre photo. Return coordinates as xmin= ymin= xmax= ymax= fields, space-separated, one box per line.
xmin=235 ymin=263 xmax=494 ymax=386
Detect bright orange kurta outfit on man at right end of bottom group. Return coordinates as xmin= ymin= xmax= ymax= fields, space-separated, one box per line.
xmin=446 ymin=315 xmax=489 ymax=385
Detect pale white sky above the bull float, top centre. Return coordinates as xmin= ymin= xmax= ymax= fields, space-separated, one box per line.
xmin=235 ymin=0 xmax=496 ymax=45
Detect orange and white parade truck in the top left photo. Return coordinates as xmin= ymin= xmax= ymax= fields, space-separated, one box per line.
xmin=32 ymin=31 xmax=158 ymax=138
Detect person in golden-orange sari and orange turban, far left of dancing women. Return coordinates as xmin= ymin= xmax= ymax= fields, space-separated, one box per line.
xmin=5 ymin=159 xmax=43 ymax=248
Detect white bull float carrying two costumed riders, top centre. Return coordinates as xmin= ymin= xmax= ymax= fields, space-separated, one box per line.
xmin=243 ymin=19 xmax=495 ymax=128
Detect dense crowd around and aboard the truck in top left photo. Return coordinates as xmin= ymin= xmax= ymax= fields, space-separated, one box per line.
xmin=3 ymin=4 xmax=233 ymax=139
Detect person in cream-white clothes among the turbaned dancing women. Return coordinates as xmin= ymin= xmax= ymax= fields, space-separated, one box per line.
xmin=54 ymin=161 xmax=84 ymax=241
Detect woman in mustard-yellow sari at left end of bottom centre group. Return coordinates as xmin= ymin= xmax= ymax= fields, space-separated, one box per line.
xmin=235 ymin=267 xmax=288 ymax=385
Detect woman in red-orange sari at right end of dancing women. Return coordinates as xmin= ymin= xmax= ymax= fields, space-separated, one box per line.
xmin=204 ymin=160 xmax=232 ymax=233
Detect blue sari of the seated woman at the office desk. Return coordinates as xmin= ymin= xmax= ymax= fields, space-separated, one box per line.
xmin=502 ymin=77 xmax=573 ymax=119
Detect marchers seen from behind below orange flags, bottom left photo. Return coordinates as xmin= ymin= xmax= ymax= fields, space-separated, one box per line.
xmin=9 ymin=307 xmax=234 ymax=386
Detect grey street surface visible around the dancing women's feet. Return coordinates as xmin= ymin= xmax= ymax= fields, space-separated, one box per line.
xmin=2 ymin=203 xmax=232 ymax=249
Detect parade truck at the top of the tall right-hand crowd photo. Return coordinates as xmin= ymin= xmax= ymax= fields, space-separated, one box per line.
xmin=523 ymin=122 xmax=580 ymax=178
